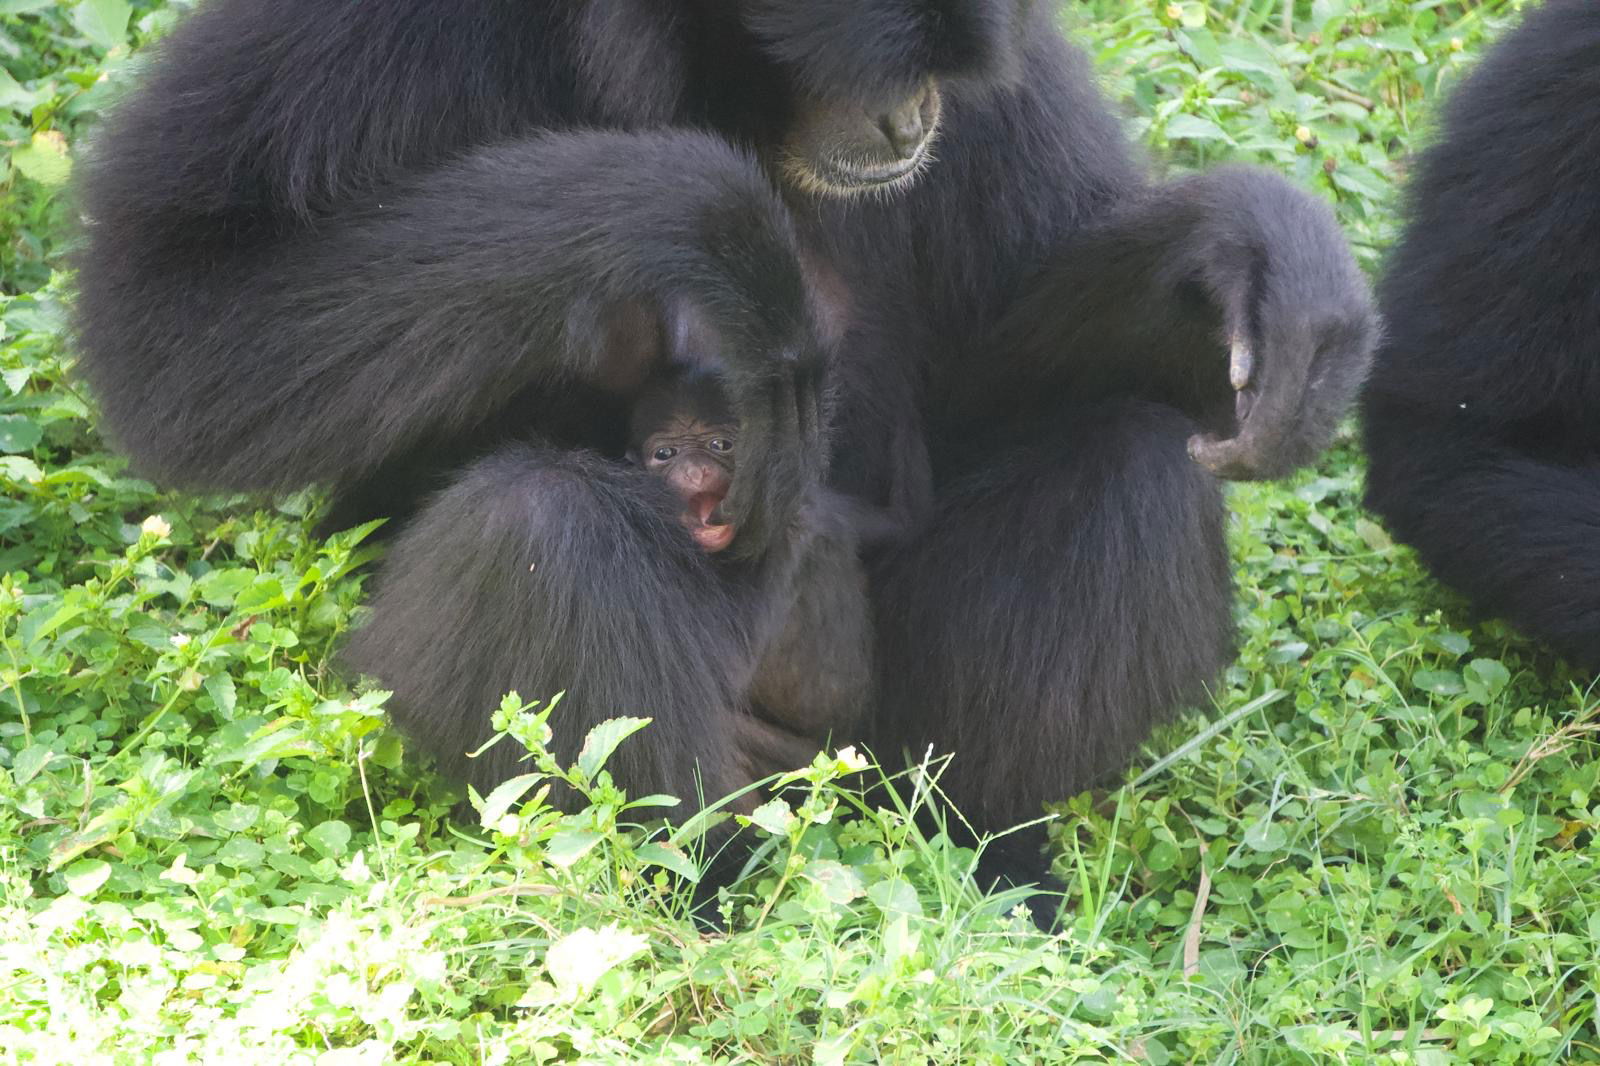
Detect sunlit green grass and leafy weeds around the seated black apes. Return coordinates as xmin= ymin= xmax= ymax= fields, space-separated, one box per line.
xmin=0 ymin=0 xmax=1600 ymax=1064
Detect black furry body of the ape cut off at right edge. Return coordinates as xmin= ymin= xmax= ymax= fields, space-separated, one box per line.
xmin=1365 ymin=0 xmax=1600 ymax=669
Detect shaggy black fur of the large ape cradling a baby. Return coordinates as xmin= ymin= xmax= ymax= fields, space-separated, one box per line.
xmin=82 ymin=0 xmax=1374 ymax=877
